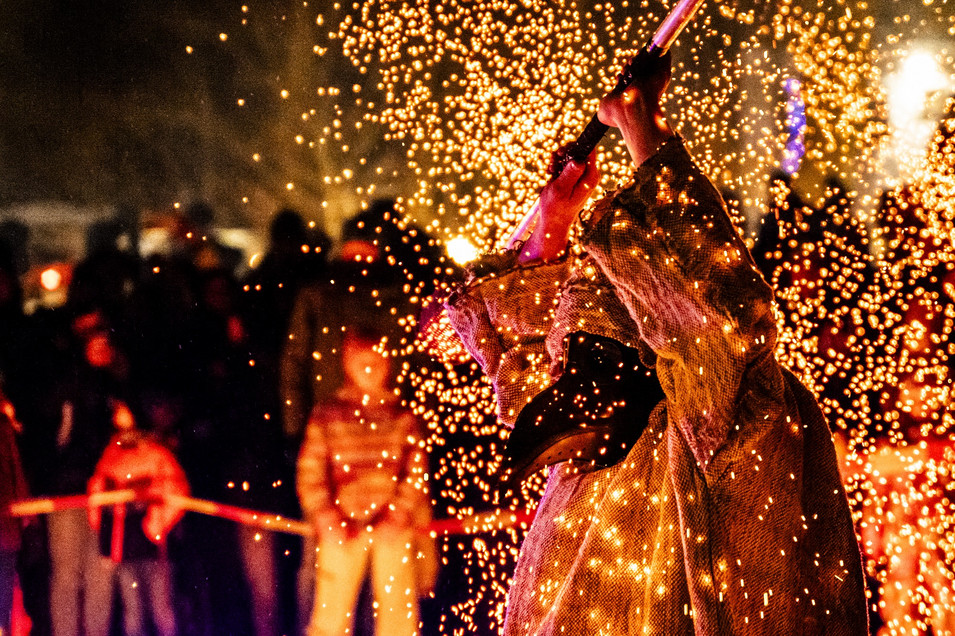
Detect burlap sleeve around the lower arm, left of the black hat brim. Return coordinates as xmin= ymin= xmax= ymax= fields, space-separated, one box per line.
xmin=447 ymin=261 xmax=569 ymax=426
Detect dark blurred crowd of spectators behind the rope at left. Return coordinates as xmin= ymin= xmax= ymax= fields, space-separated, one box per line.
xmin=0 ymin=201 xmax=442 ymax=636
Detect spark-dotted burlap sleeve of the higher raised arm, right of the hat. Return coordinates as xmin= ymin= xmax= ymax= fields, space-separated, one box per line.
xmin=584 ymin=138 xmax=775 ymax=470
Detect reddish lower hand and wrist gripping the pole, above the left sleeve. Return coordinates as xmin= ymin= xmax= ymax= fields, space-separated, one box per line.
xmin=520 ymin=155 xmax=600 ymax=262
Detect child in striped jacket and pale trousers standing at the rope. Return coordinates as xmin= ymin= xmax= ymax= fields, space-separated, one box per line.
xmin=297 ymin=328 xmax=430 ymax=636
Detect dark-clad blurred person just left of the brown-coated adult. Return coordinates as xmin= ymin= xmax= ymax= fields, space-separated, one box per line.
xmin=239 ymin=209 xmax=330 ymax=636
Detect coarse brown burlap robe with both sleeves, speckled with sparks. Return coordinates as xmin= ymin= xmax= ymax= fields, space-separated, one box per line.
xmin=449 ymin=137 xmax=867 ymax=636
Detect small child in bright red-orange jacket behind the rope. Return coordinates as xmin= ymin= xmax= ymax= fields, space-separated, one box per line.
xmin=88 ymin=403 xmax=189 ymax=636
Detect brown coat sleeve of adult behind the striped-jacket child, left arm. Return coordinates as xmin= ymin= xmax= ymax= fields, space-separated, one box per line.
xmin=280 ymin=288 xmax=319 ymax=439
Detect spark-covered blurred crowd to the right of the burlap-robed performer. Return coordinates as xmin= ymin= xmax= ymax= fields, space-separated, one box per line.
xmin=753 ymin=98 xmax=955 ymax=635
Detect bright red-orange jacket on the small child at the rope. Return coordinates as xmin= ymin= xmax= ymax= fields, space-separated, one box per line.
xmin=87 ymin=431 xmax=189 ymax=545
